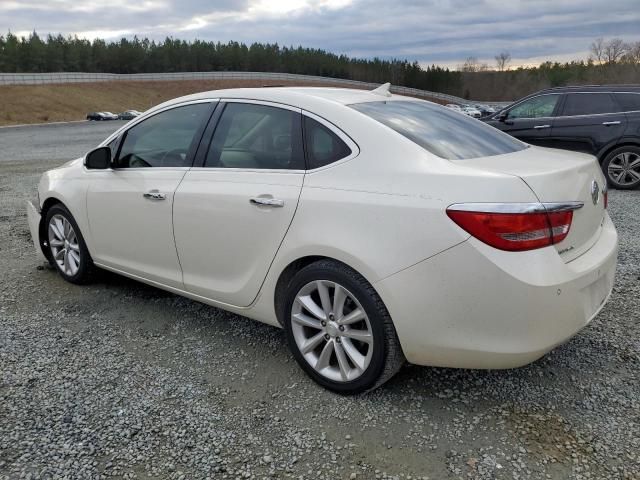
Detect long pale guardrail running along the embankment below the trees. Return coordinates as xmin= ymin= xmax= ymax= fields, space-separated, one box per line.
xmin=0 ymin=72 xmax=511 ymax=105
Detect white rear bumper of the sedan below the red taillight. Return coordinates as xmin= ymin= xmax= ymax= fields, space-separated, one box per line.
xmin=375 ymin=215 xmax=618 ymax=368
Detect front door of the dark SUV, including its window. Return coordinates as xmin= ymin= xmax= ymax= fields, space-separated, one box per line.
xmin=490 ymin=93 xmax=562 ymax=146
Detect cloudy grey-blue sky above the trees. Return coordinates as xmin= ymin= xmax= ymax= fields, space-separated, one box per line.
xmin=0 ymin=0 xmax=640 ymax=67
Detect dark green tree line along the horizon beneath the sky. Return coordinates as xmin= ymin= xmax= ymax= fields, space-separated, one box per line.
xmin=0 ymin=32 xmax=640 ymax=101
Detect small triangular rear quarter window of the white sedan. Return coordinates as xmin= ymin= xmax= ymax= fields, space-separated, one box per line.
xmin=304 ymin=117 xmax=351 ymax=170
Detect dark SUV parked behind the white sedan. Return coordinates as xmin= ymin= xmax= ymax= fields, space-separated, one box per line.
xmin=485 ymin=85 xmax=640 ymax=189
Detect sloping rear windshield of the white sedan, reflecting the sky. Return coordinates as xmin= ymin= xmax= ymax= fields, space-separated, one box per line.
xmin=350 ymin=101 xmax=528 ymax=160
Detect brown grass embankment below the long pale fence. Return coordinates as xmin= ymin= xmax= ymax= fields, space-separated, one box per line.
xmin=0 ymin=80 xmax=448 ymax=125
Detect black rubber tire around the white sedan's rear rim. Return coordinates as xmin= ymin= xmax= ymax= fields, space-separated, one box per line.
xmin=283 ymin=265 xmax=387 ymax=395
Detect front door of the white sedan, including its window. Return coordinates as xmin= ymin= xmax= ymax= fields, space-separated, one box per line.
xmin=87 ymin=102 xmax=212 ymax=288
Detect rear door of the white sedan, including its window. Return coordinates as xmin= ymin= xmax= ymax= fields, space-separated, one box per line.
xmin=173 ymin=100 xmax=305 ymax=306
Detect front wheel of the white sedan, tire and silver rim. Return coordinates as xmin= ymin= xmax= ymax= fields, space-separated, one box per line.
xmin=45 ymin=204 xmax=95 ymax=284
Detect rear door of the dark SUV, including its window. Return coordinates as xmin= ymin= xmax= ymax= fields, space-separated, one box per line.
xmin=551 ymin=92 xmax=627 ymax=155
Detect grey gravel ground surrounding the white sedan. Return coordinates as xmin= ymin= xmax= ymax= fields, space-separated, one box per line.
xmin=0 ymin=124 xmax=640 ymax=480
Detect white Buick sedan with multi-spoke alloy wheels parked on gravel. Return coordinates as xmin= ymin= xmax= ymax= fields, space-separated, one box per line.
xmin=28 ymin=86 xmax=618 ymax=394
